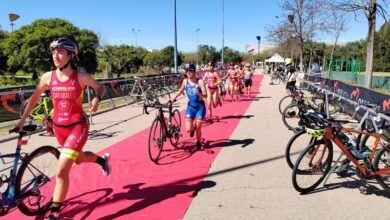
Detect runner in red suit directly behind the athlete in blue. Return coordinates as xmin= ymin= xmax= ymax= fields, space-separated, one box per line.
xmin=203 ymin=61 xmax=222 ymax=120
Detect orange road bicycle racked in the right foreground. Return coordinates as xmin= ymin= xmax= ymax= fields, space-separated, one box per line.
xmin=292 ymin=115 xmax=390 ymax=193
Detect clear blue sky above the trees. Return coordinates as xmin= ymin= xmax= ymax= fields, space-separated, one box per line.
xmin=0 ymin=0 xmax=390 ymax=52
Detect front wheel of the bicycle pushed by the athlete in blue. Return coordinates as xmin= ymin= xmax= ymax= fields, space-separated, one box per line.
xmin=148 ymin=117 xmax=164 ymax=163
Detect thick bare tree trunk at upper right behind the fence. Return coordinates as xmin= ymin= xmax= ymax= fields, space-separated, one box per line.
xmin=364 ymin=0 xmax=376 ymax=89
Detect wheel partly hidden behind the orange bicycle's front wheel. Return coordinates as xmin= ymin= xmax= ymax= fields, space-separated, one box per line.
xmin=285 ymin=129 xmax=317 ymax=169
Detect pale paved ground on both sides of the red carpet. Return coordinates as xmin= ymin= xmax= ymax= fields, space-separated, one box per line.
xmin=0 ymin=74 xmax=390 ymax=220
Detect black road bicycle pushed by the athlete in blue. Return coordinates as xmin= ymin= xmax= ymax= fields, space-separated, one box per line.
xmin=143 ymin=101 xmax=181 ymax=163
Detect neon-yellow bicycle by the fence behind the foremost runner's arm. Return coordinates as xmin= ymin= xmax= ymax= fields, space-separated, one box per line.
xmin=20 ymin=90 xmax=54 ymax=136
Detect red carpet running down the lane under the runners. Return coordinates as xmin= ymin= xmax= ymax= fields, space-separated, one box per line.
xmin=9 ymin=75 xmax=263 ymax=220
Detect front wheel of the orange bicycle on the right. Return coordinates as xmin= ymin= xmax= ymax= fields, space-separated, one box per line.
xmin=292 ymin=140 xmax=333 ymax=193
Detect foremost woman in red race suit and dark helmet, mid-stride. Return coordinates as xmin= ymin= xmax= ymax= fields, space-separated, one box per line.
xmin=16 ymin=37 xmax=111 ymax=220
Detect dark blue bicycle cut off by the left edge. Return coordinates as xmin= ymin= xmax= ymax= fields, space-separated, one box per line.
xmin=0 ymin=125 xmax=60 ymax=216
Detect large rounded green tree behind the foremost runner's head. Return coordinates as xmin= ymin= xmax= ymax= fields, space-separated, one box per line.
xmin=3 ymin=19 xmax=97 ymax=79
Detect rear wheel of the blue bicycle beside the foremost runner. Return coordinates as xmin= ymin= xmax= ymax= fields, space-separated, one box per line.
xmin=15 ymin=146 xmax=60 ymax=216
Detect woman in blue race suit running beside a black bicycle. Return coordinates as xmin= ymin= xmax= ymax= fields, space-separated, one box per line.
xmin=172 ymin=63 xmax=207 ymax=149
